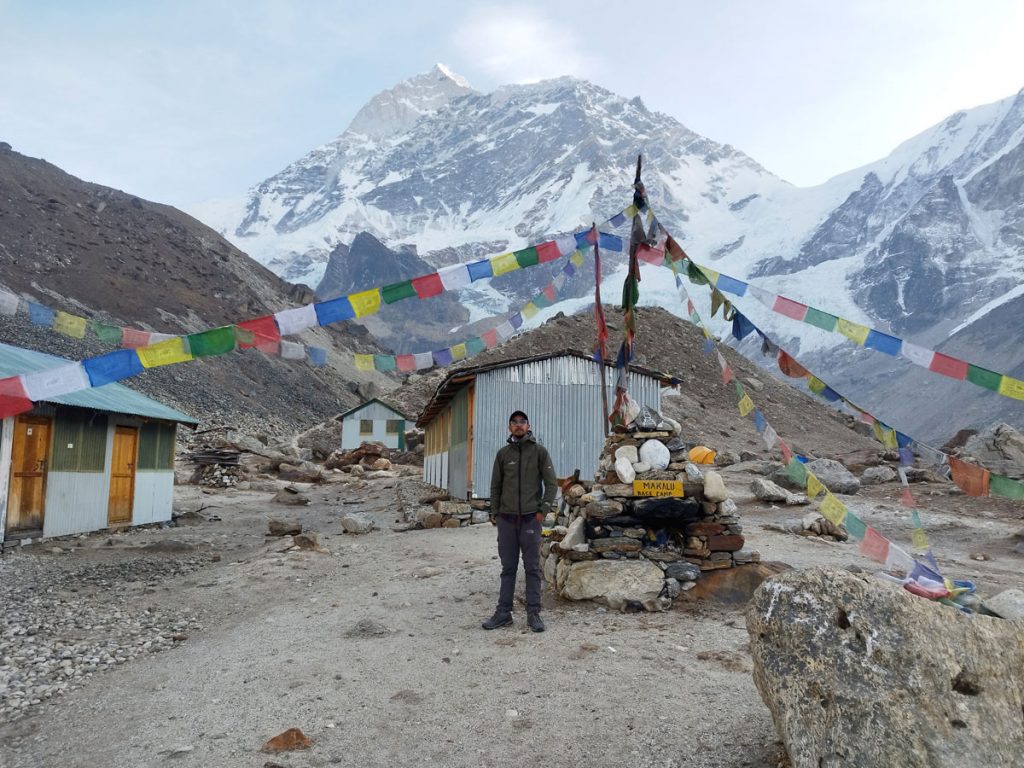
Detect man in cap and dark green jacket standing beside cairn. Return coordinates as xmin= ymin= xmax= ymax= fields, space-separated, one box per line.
xmin=482 ymin=411 xmax=558 ymax=632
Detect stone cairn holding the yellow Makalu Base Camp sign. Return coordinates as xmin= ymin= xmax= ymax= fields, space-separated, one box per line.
xmin=542 ymin=409 xmax=760 ymax=610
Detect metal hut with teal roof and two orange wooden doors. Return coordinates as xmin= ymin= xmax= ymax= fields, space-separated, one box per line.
xmin=0 ymin=344 xmax=198 ymax=542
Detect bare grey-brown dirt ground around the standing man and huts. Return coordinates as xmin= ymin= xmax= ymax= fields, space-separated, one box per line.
xmin=0 ymin=473 xmax=1024 ymax=768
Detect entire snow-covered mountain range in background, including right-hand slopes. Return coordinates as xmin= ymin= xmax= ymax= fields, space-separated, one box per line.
xmin=197 ymin=67 xmax=1024 ymax=442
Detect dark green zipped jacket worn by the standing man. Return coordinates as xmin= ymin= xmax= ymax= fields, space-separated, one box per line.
xmin=490 ymin=432 xmax=558 ymax=515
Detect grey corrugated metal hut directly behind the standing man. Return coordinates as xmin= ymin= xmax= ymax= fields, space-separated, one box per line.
xmin=417 ymin=350 xmax=669 ymax=499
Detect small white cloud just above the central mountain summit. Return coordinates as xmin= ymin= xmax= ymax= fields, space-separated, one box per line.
xmin=452 ymin=6 xmax=597 ymax=83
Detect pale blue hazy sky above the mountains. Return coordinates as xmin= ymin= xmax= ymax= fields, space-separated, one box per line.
xmin=0 ymin=0 xmax=1024 ymax=209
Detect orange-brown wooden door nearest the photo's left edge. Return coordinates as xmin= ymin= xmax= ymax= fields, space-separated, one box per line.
xmin=7 ymin=416 xmax=51 ymax=534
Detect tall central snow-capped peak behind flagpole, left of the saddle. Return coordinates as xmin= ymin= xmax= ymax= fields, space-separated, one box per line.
xmin=198 ymin=68 xmax=792 ymax=287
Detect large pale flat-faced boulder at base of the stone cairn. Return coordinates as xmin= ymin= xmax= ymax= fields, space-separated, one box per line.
xmin=560 ymin=560 xmax=665 ymax=610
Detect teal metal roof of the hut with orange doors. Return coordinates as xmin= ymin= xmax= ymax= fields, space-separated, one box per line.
xmin=0 ymin=343 xmax=199 ymax=424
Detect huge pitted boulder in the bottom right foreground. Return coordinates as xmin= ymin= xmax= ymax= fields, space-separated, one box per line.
xmin=746 ymin=568 xmax=1024 ymax=768
